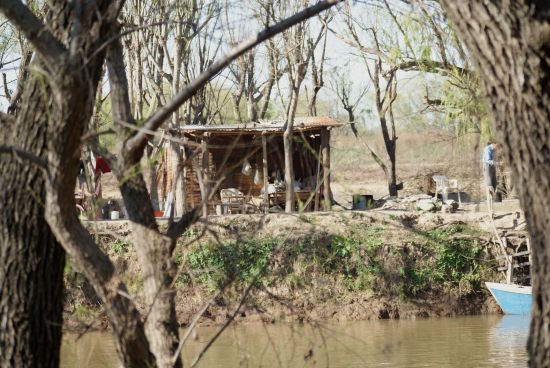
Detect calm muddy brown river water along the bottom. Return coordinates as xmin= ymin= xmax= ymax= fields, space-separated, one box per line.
xmin=62 ymin=316 xmax=529 ymax=368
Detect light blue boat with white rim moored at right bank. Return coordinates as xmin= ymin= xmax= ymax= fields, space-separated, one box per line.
xmin=485 ymin=282 xmax=532 ymax=315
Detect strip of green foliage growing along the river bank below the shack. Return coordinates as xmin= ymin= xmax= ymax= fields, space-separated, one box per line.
xmin=183 ymin=224 xmax=490 ymax=298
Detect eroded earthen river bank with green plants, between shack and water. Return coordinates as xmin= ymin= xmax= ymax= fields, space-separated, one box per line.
xmin=65 ymin=211 xmax=520 ymax=330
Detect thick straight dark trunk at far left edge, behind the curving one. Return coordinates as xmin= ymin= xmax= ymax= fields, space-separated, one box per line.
xmin=0 ymin=76 xmax=65 ymax=367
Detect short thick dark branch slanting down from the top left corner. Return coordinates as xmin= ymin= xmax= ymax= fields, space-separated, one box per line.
xmin=0 ymin=0 xmax=67 ymax=65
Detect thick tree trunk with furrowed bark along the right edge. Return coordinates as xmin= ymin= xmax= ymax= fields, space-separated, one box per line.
xmin=443 ymin=0 xmax=550 ymax=367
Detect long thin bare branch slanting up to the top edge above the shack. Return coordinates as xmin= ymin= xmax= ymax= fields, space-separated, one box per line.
xmin=127 ymin=0 xmax=343 ymax=155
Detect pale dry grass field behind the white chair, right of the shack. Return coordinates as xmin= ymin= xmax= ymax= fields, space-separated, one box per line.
xmin=332 ymin=129 xmax=482 ymax=202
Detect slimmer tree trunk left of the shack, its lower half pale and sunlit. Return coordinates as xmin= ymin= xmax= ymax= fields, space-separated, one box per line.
xmin=107 ymin=42 xmax=181 ymax=367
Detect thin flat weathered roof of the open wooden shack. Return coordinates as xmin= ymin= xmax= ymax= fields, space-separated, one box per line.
xmin=177 ymin=117 xmax=342 ymax=135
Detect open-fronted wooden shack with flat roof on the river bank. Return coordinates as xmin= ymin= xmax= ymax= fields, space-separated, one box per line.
xmin=158 ymin=117 xmax=341 ymax=215
